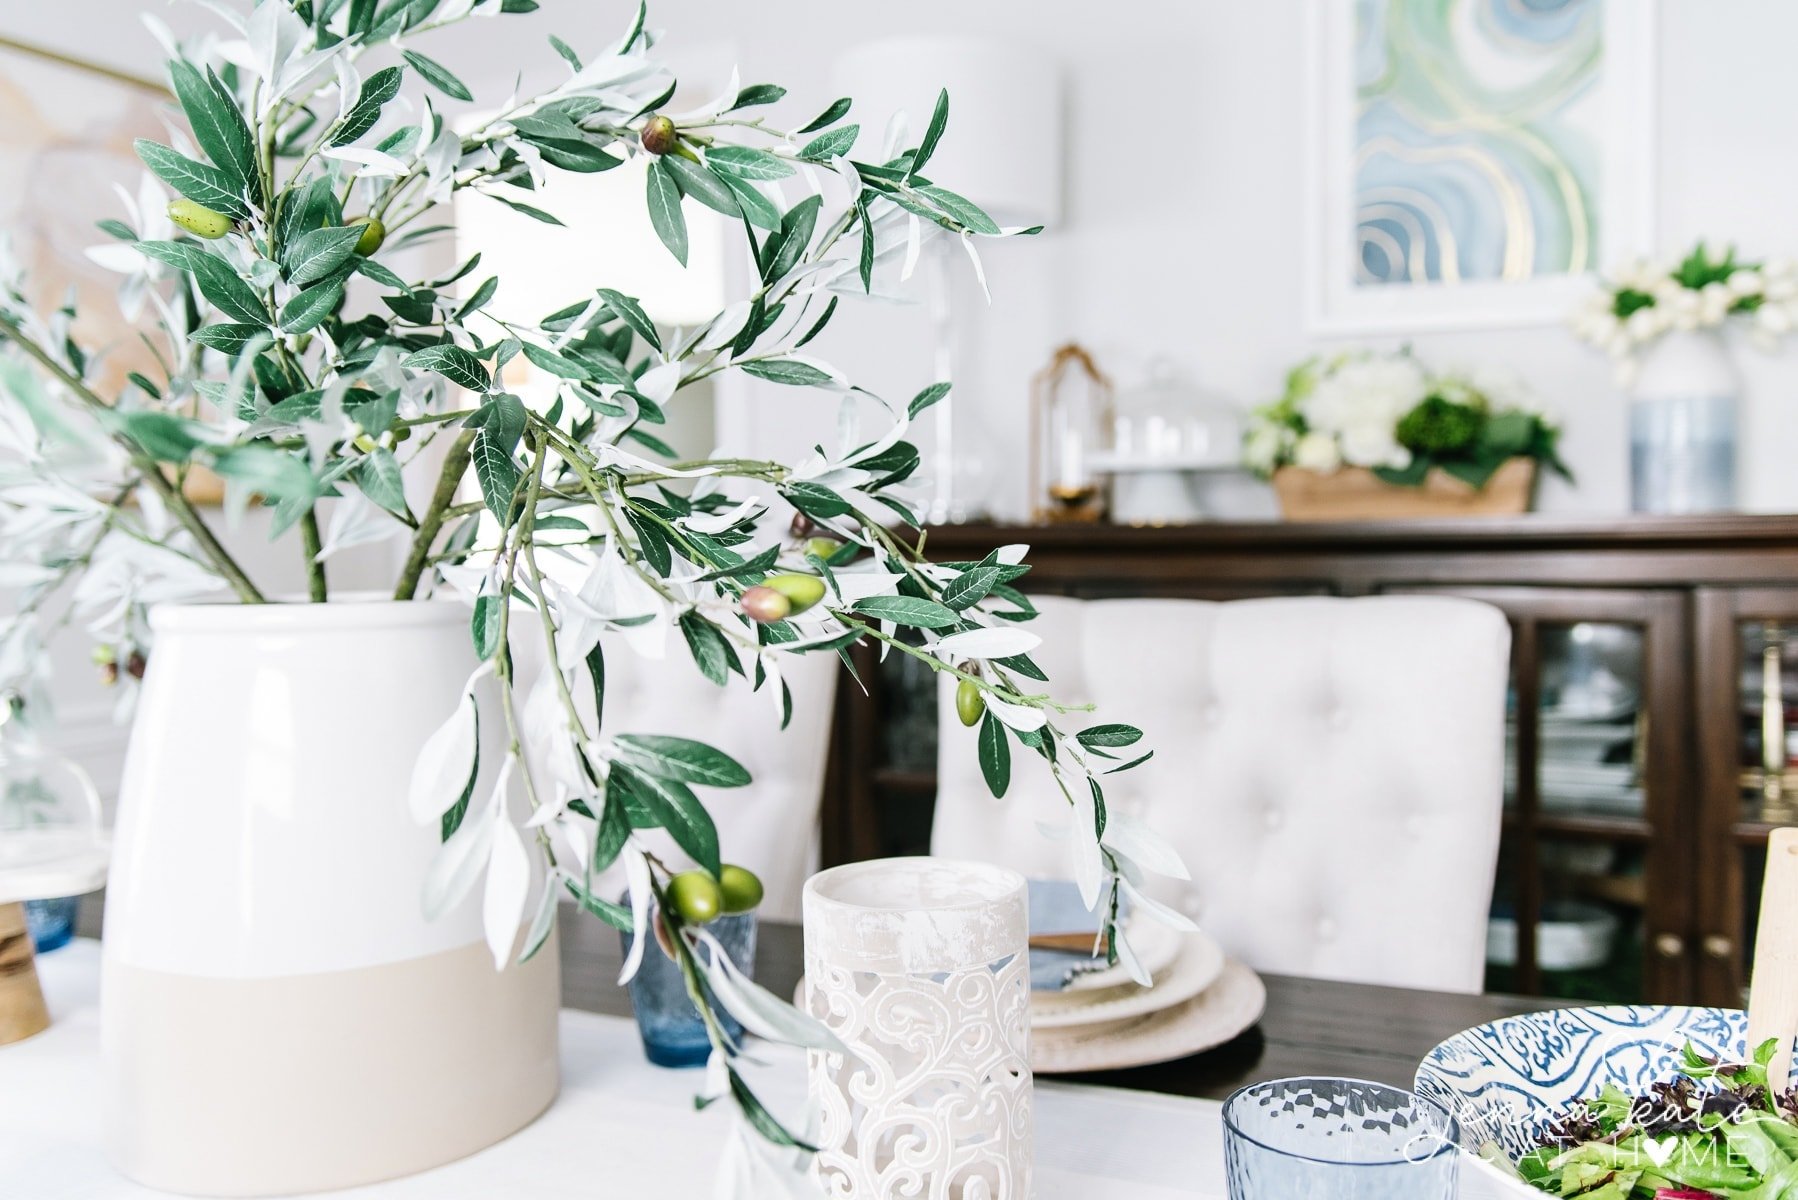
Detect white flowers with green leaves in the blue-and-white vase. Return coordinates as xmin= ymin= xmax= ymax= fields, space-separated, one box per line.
xmin=1571 ymin=243 xmax=1798 ymax=383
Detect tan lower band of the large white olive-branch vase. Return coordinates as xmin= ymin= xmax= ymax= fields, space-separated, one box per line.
xmin=101 ymin=943 xmax=561 ymax=1196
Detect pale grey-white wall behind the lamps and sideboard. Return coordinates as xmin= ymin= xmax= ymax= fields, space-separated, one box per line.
xmin=10 ymin=0 xmax=1798 ymax=784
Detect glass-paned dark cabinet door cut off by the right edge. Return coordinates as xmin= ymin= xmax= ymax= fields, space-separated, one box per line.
xmin=1694 ymin=588 xmax=1798 ymax=1007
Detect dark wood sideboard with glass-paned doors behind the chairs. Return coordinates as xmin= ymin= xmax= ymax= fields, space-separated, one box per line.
xmin=823 ymin=515 xmax=1798 ymax=1004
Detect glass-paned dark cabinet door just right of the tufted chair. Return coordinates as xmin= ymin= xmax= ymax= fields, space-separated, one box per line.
xmin=1402 ymin=588 xmax=1690 ymax=1002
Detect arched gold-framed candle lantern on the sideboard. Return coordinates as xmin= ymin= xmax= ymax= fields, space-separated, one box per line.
xmin=1030 ymin=342 xmax=1113 ymax=524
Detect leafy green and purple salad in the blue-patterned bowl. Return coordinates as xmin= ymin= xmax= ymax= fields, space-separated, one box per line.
xmin=1518 ymin=1038 xmax=1798 ymax=1200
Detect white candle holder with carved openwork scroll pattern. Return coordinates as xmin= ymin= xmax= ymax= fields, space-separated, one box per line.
xmin=804 ymin=858 xmax=1032 ymax=1200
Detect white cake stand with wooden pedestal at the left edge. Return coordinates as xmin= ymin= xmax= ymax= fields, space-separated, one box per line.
xmin=0 ymin=775 xmax=110 ymax=1045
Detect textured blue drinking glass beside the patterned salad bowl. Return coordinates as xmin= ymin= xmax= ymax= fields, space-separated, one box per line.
xmin=1224 ymin=1079 xmax=1460 ymax=1200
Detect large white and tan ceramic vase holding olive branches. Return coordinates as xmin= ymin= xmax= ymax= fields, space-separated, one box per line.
xmin=101 ymin=601 xmax=561 ymax=1196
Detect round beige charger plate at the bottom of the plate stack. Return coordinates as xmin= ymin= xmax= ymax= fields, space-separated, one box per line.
xmin=1030 ymin=959 xmax=1268 ymax=1076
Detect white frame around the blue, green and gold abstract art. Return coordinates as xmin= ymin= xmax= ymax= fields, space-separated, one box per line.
xmin=1304 ymin=0 xmax=1656 ymax=336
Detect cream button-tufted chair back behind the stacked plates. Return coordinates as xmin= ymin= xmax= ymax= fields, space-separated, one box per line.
xmin=931 ymin=596 xmax=1510 ymax=991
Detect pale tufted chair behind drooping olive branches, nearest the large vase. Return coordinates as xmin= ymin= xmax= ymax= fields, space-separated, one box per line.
xmin=571 ymin=635 xmax=841 ymax=921
